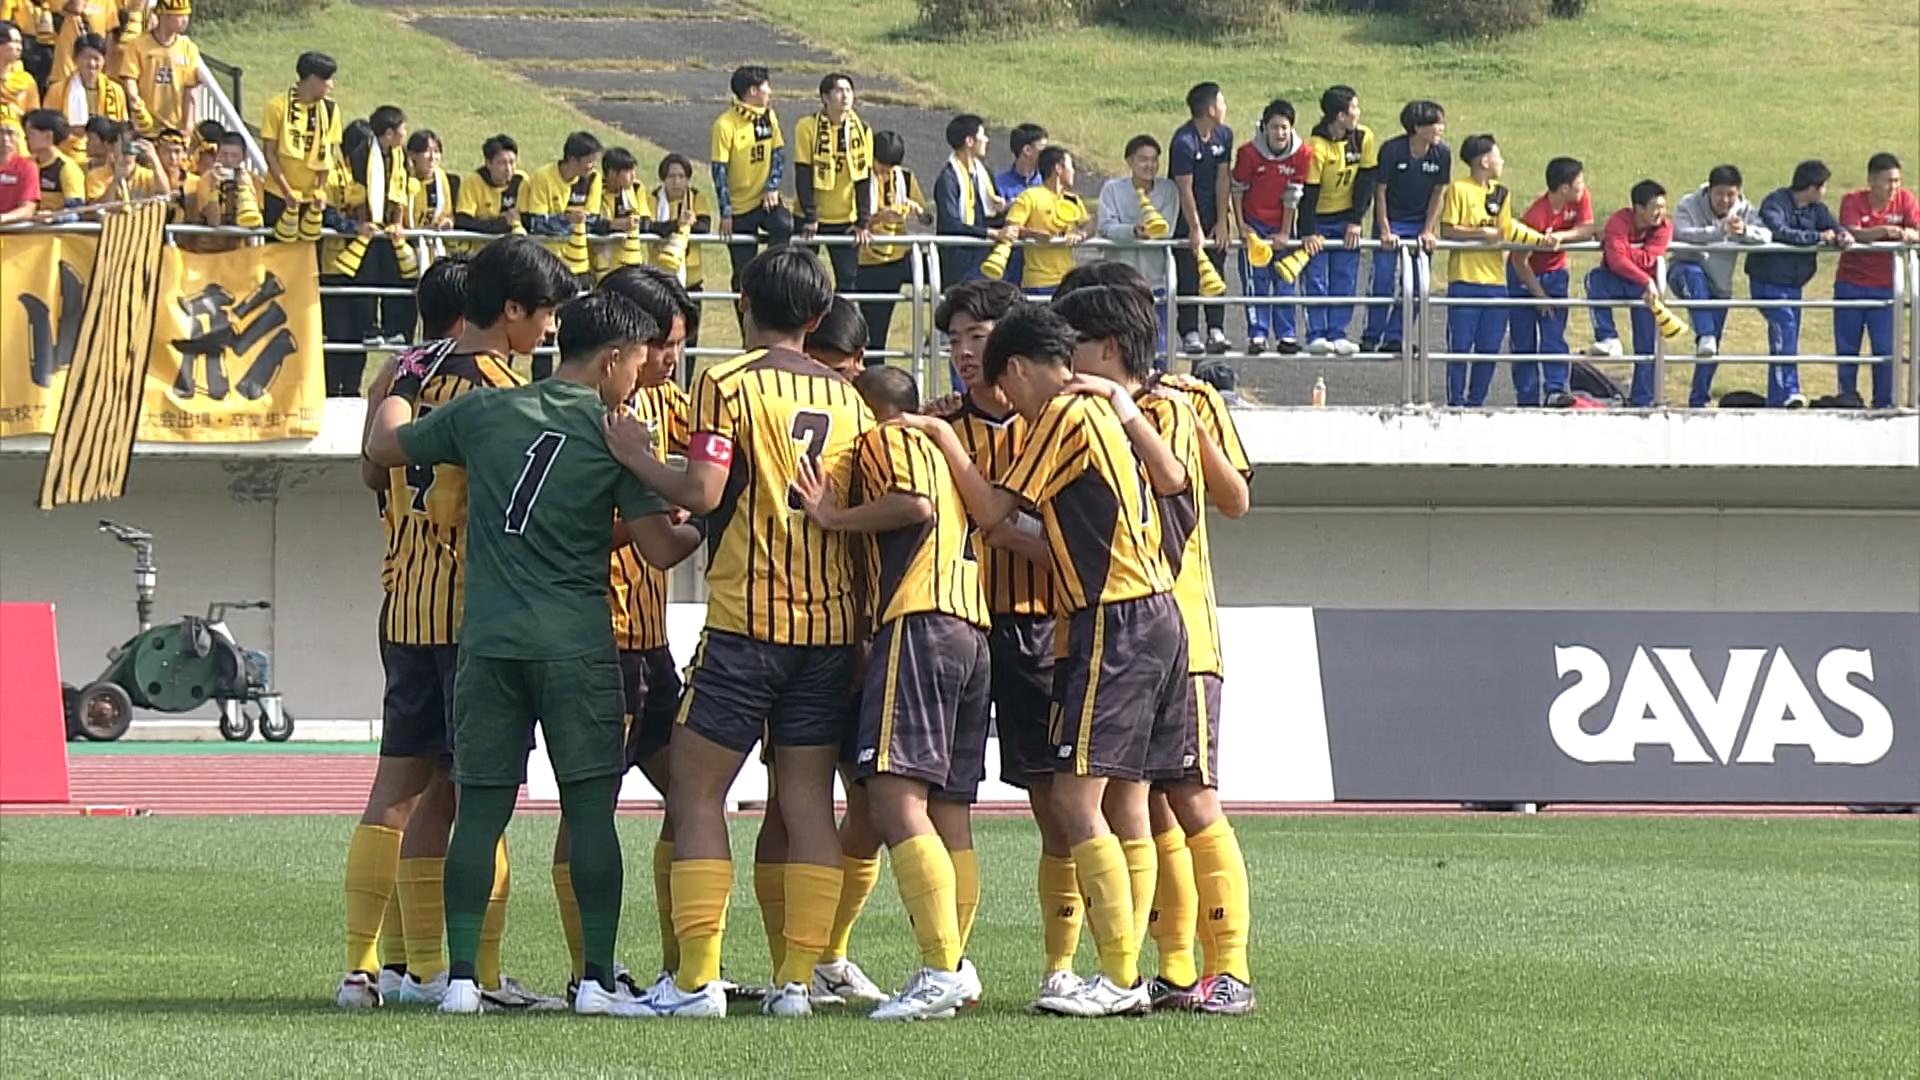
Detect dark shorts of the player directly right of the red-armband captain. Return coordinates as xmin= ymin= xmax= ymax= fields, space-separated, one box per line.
xmin=852 ymin=611 xmax=989 ymax=803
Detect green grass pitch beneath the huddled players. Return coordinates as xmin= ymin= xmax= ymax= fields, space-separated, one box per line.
xmin=0 ymin=815 xmax=1920 ymax=1080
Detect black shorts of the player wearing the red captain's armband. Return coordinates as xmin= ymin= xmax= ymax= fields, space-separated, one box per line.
xmin=676 ymin=630 xmax=852 ymax=753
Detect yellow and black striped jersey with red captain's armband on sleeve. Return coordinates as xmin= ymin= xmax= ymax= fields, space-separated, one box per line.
xmin=691 ymin=350 xmax=874 ymax=646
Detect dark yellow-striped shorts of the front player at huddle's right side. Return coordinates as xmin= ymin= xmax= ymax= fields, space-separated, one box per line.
xmin=1052 ymin=594 xmax=1187 ymax=780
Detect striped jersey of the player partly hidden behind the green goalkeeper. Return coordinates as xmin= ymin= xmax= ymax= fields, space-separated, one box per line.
xmin=382 ymin=342 xmax=522 ymax=646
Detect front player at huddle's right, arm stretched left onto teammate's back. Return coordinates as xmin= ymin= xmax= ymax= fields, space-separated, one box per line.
xmin=906 ymin=307 xmax=1187 ymax=1017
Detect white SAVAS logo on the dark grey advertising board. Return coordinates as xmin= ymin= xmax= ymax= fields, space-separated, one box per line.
xmin=1548 ymin=646 xmax=1893 ymax=765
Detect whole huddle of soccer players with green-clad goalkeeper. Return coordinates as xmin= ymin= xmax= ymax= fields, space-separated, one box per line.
xmin=349 ymin=228 xmax=1254 ymax=1020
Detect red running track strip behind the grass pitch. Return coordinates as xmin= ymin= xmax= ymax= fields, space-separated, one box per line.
xmin=0 ymin=753 xmax=1843 ymax=817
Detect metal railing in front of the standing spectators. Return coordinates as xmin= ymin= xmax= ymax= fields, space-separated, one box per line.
xmin=0 ymin=223 xmax=1920 ymax=409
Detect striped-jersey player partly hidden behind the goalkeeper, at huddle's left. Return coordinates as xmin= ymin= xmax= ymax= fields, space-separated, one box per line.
xmin=357 ymin=238 xmax=572 ymax=1003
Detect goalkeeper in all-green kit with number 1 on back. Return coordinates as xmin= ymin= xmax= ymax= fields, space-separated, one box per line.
xmin=369 ymin=282 xmax=697 ymax=1017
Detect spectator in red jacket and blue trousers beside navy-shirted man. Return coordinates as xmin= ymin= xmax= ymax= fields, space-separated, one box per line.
xmin=1233 ymin=98 xmax=1313 ymax=356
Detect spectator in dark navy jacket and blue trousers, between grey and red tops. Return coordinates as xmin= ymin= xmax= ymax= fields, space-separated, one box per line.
xmin=1747 ymin=161 xmax=1853 ymax=409
